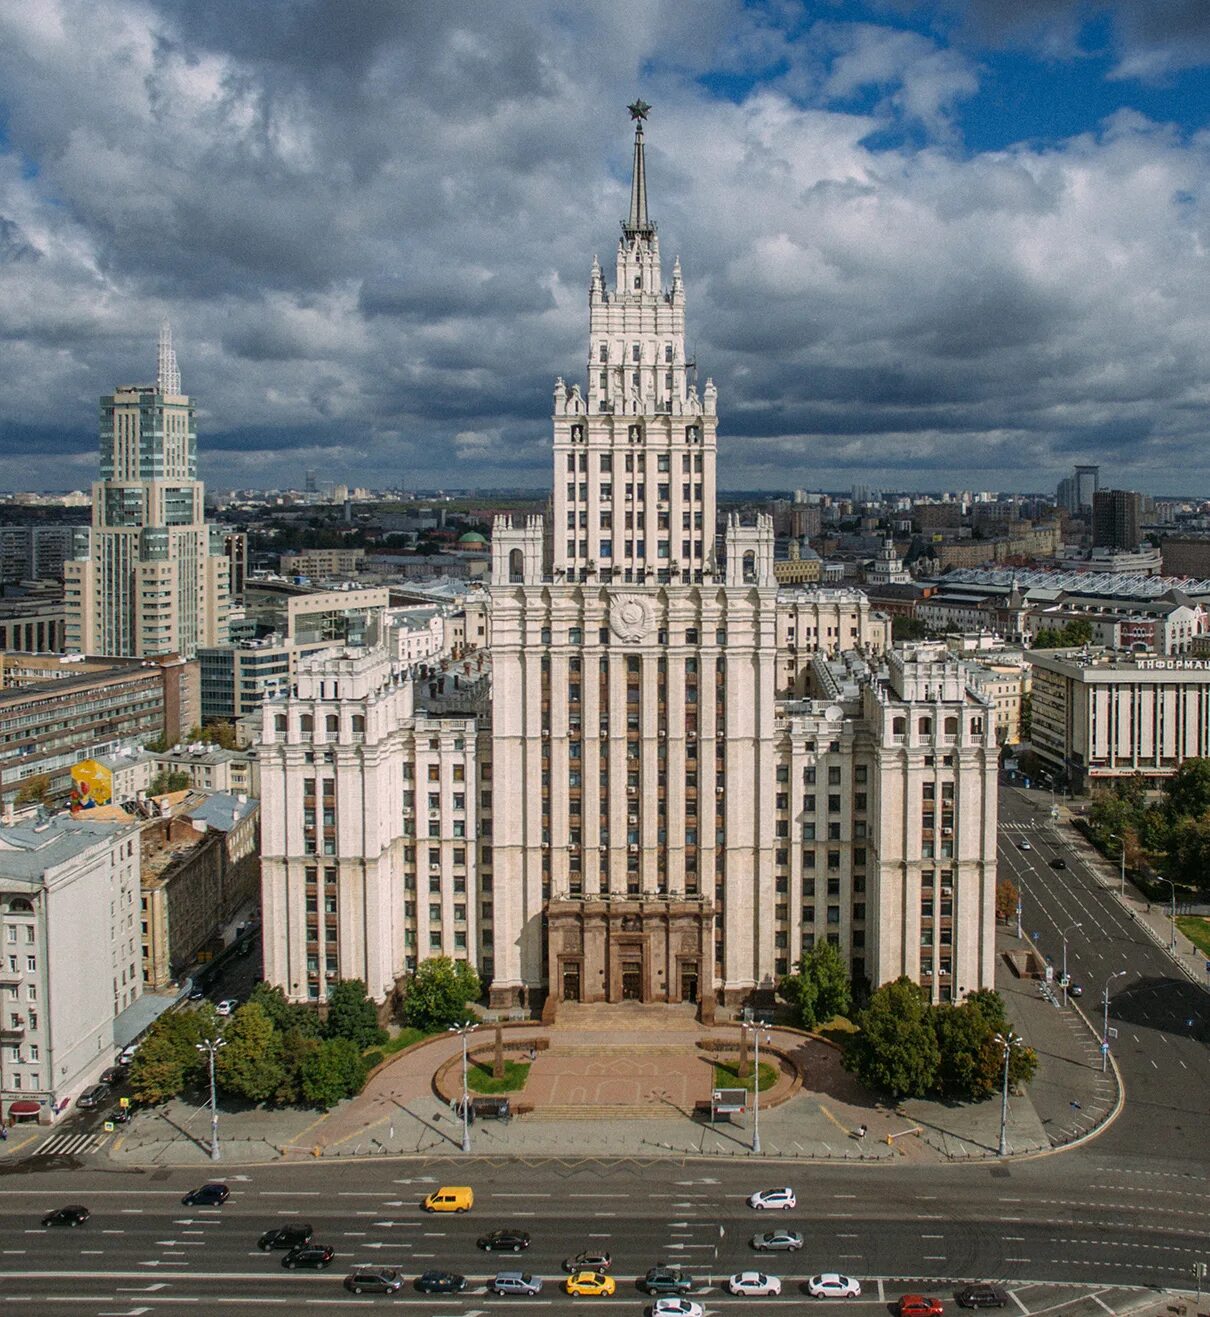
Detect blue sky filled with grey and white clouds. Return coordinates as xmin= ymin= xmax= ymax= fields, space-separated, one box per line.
xmin=0 ymin=0 xmax=1210 ymax=494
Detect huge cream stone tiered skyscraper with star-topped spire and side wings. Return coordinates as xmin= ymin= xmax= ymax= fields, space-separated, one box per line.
xmin=252 ymin=113 xmax=997 ymax=1013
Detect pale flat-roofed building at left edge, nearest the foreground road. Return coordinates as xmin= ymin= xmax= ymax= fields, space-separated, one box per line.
xmin=0 ymin=815 xmax=142 ymax=1121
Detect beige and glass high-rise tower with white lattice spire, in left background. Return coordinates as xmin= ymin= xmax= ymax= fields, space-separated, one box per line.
xmin=65 ymin=321 xmax=229 ymax=659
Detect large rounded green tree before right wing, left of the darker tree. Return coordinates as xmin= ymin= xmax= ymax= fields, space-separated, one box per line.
xmin=844 ymin=976 xmax=941 ymax=1097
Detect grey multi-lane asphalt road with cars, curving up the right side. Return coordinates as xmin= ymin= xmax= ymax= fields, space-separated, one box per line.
xmin=0 ymin=790 xmax=1210 ymax=1317
